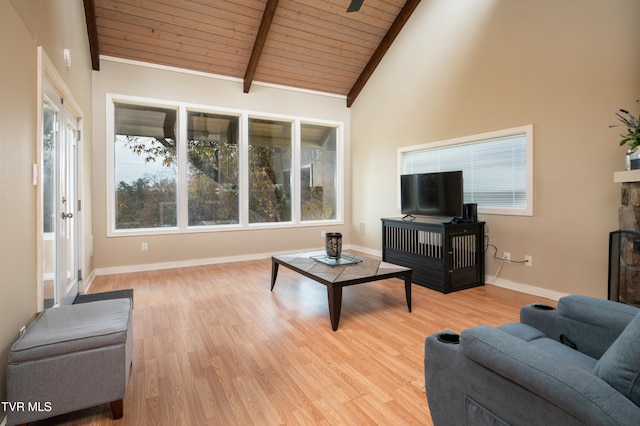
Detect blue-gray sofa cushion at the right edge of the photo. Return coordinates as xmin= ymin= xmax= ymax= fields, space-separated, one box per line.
xmin=593 ymin=314 xmax=640 ymax=406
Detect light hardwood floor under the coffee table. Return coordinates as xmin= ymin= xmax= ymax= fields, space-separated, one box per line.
xmin=33 ymin=255 xmax=556 ymax=426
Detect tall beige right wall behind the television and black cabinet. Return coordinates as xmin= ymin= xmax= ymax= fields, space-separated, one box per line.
xmin=351 ymin=0 xmax=640 ymax=298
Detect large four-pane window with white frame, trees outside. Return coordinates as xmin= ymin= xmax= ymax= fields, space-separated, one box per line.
xmin=107 ymin=95 xmax=342 ymax=235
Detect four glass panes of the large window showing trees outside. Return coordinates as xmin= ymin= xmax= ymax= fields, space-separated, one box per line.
xmin=114 ymin=103 xmax=337 ymax=229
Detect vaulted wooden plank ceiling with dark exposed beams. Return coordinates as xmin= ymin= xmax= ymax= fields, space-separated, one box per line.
xmin=84 ymin=0 xmax=420 ymax=106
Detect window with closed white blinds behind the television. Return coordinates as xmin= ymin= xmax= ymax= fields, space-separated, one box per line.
xmin=399 ymin=126 xmax=533 ymax=216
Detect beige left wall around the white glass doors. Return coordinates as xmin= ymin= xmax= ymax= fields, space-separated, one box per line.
xmin=0 ymin=0 xmax=91 ymax=406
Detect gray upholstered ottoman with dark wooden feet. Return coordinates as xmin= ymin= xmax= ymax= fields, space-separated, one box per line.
xmin=7 ymin=299 xmax=133 ymax=425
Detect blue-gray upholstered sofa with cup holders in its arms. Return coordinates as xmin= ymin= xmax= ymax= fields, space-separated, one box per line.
xmin=424 ymin=295 xmax=640 ymax=426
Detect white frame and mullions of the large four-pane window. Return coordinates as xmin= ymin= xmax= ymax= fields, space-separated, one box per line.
xmin=105 ymin=93 xmax=344 ymax=237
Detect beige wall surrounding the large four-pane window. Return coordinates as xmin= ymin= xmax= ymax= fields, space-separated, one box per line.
xmin=93 ymin=58 xmax=351 ymax=274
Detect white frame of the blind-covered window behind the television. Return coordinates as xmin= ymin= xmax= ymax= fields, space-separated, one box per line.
xmin=397 ymin=124 xmax=534 ymax=216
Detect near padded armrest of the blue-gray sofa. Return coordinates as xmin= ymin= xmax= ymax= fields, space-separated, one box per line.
xmin=460 ymin=326 xmax=640 ymax=425
